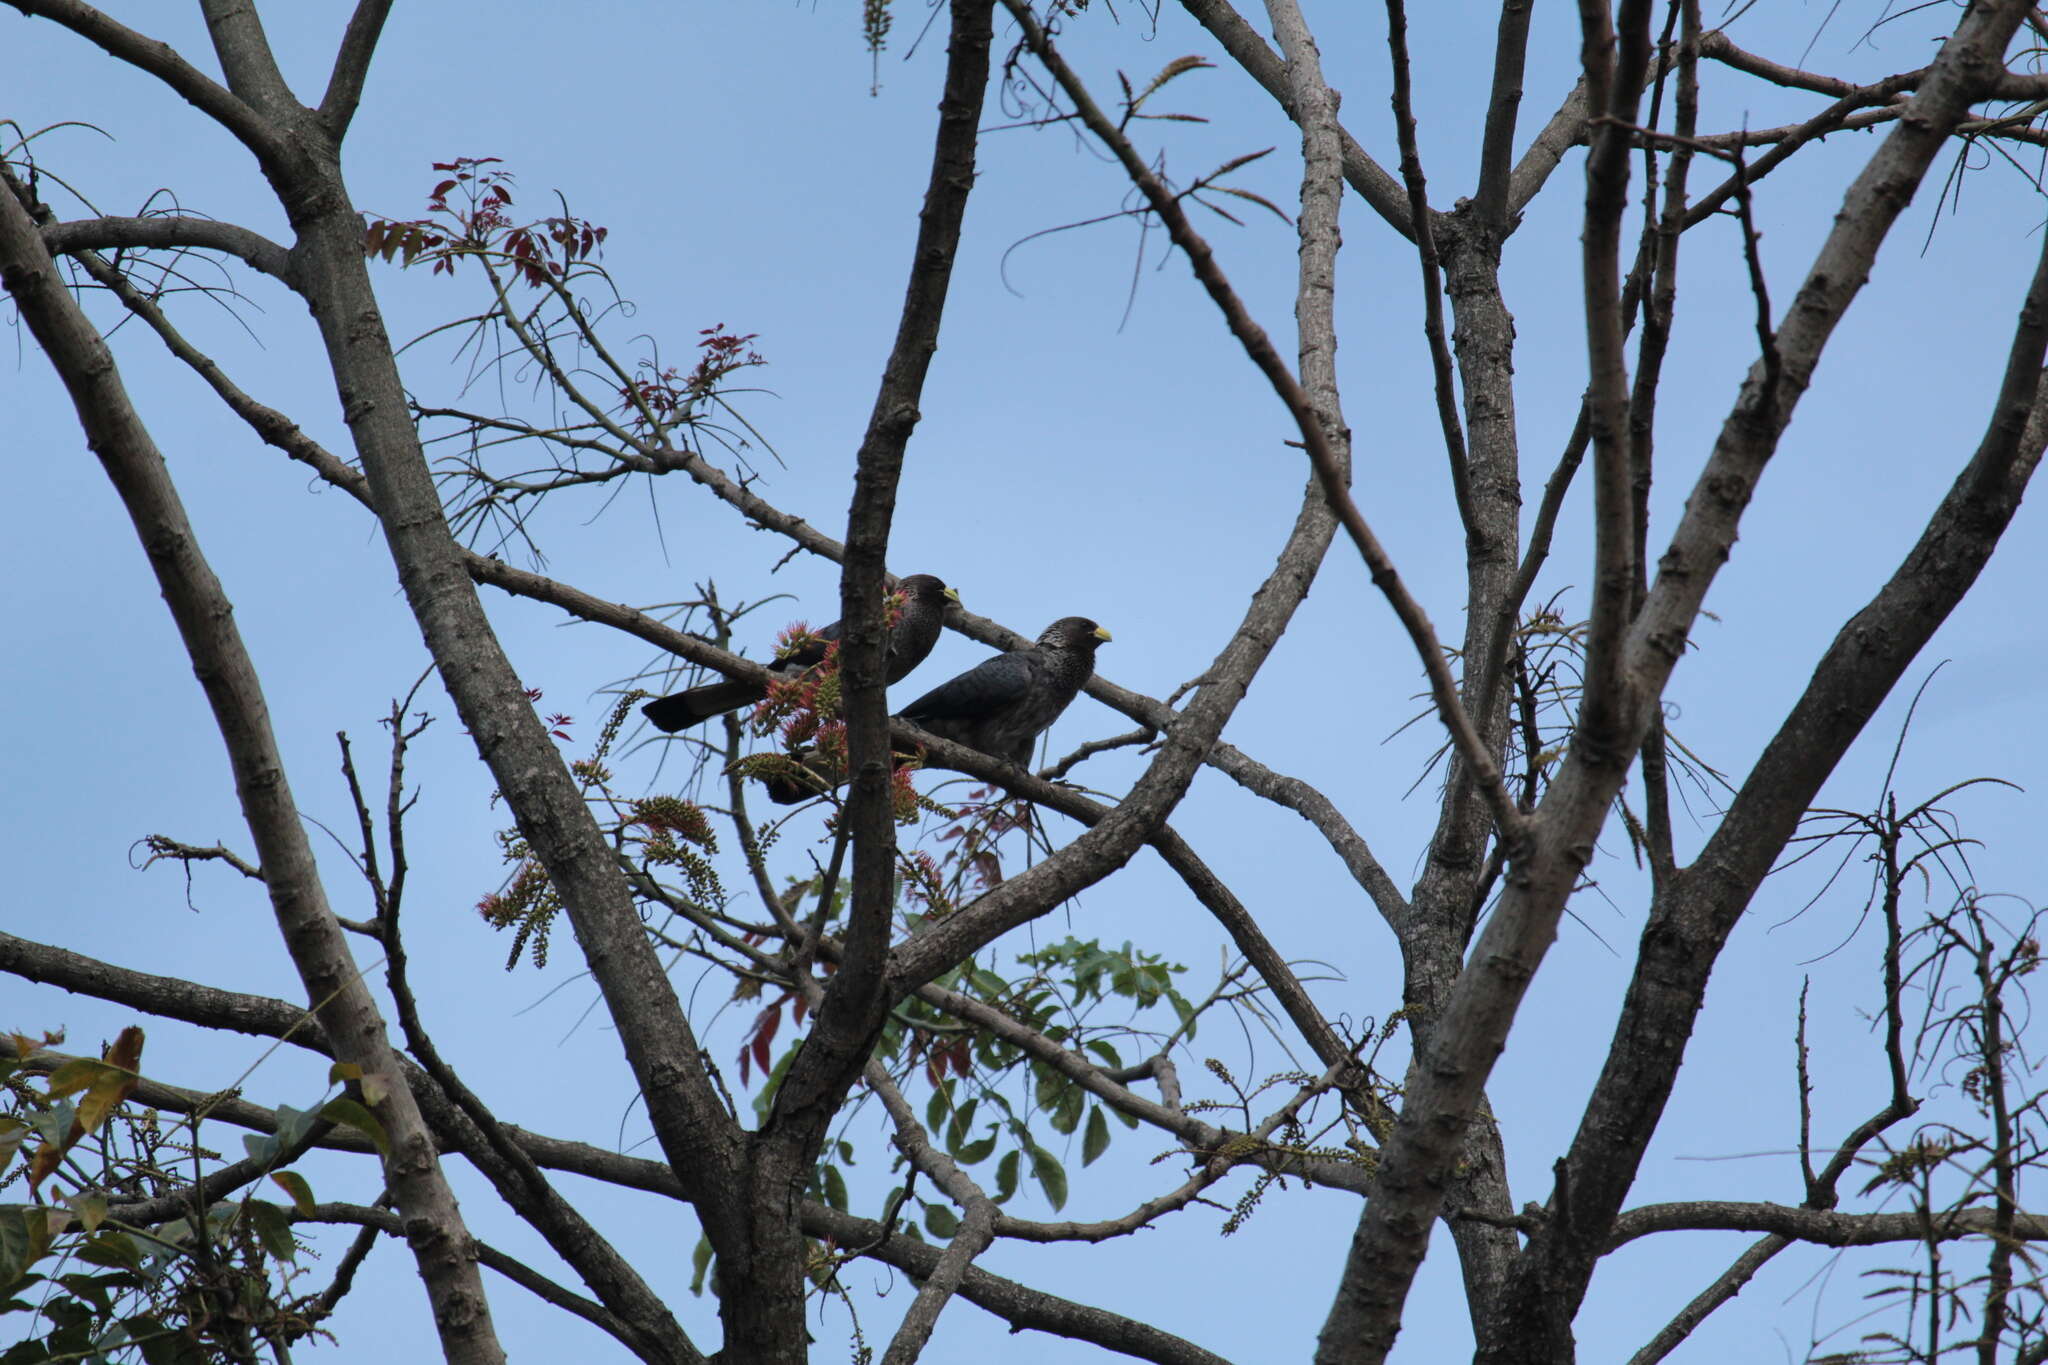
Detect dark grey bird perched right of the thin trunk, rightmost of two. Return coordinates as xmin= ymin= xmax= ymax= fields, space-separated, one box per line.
xmin=764 ymin=616 xmax=1110 ymax=806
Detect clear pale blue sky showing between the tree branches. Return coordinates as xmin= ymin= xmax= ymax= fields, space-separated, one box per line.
xmin=0 ymin=0 xmax=2048 ymax=1361
